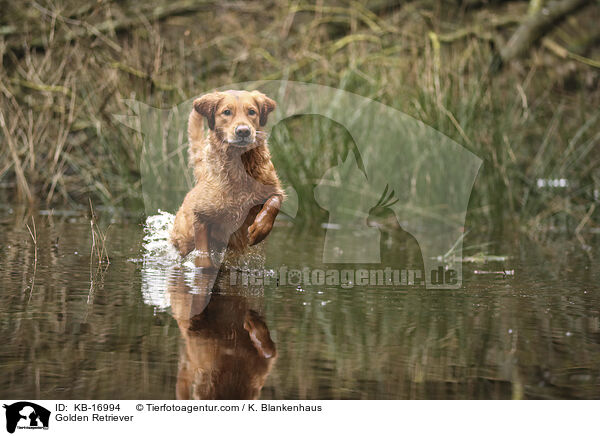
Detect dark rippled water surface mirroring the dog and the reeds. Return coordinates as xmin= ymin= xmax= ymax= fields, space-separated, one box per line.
xmin=0 ymin=210 xmax=600 ymax=399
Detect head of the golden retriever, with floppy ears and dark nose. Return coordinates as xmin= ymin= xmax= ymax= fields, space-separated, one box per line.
xmin=194 ymin=91 xmax=276 ymax=148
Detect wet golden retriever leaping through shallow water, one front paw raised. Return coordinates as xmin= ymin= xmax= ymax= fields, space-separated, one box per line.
xmin=171 ymin=91 xmax=284 ymax=268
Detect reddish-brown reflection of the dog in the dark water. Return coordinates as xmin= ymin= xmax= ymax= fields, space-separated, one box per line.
xmin=169 ymin=269 xmax=277 ymax=400
